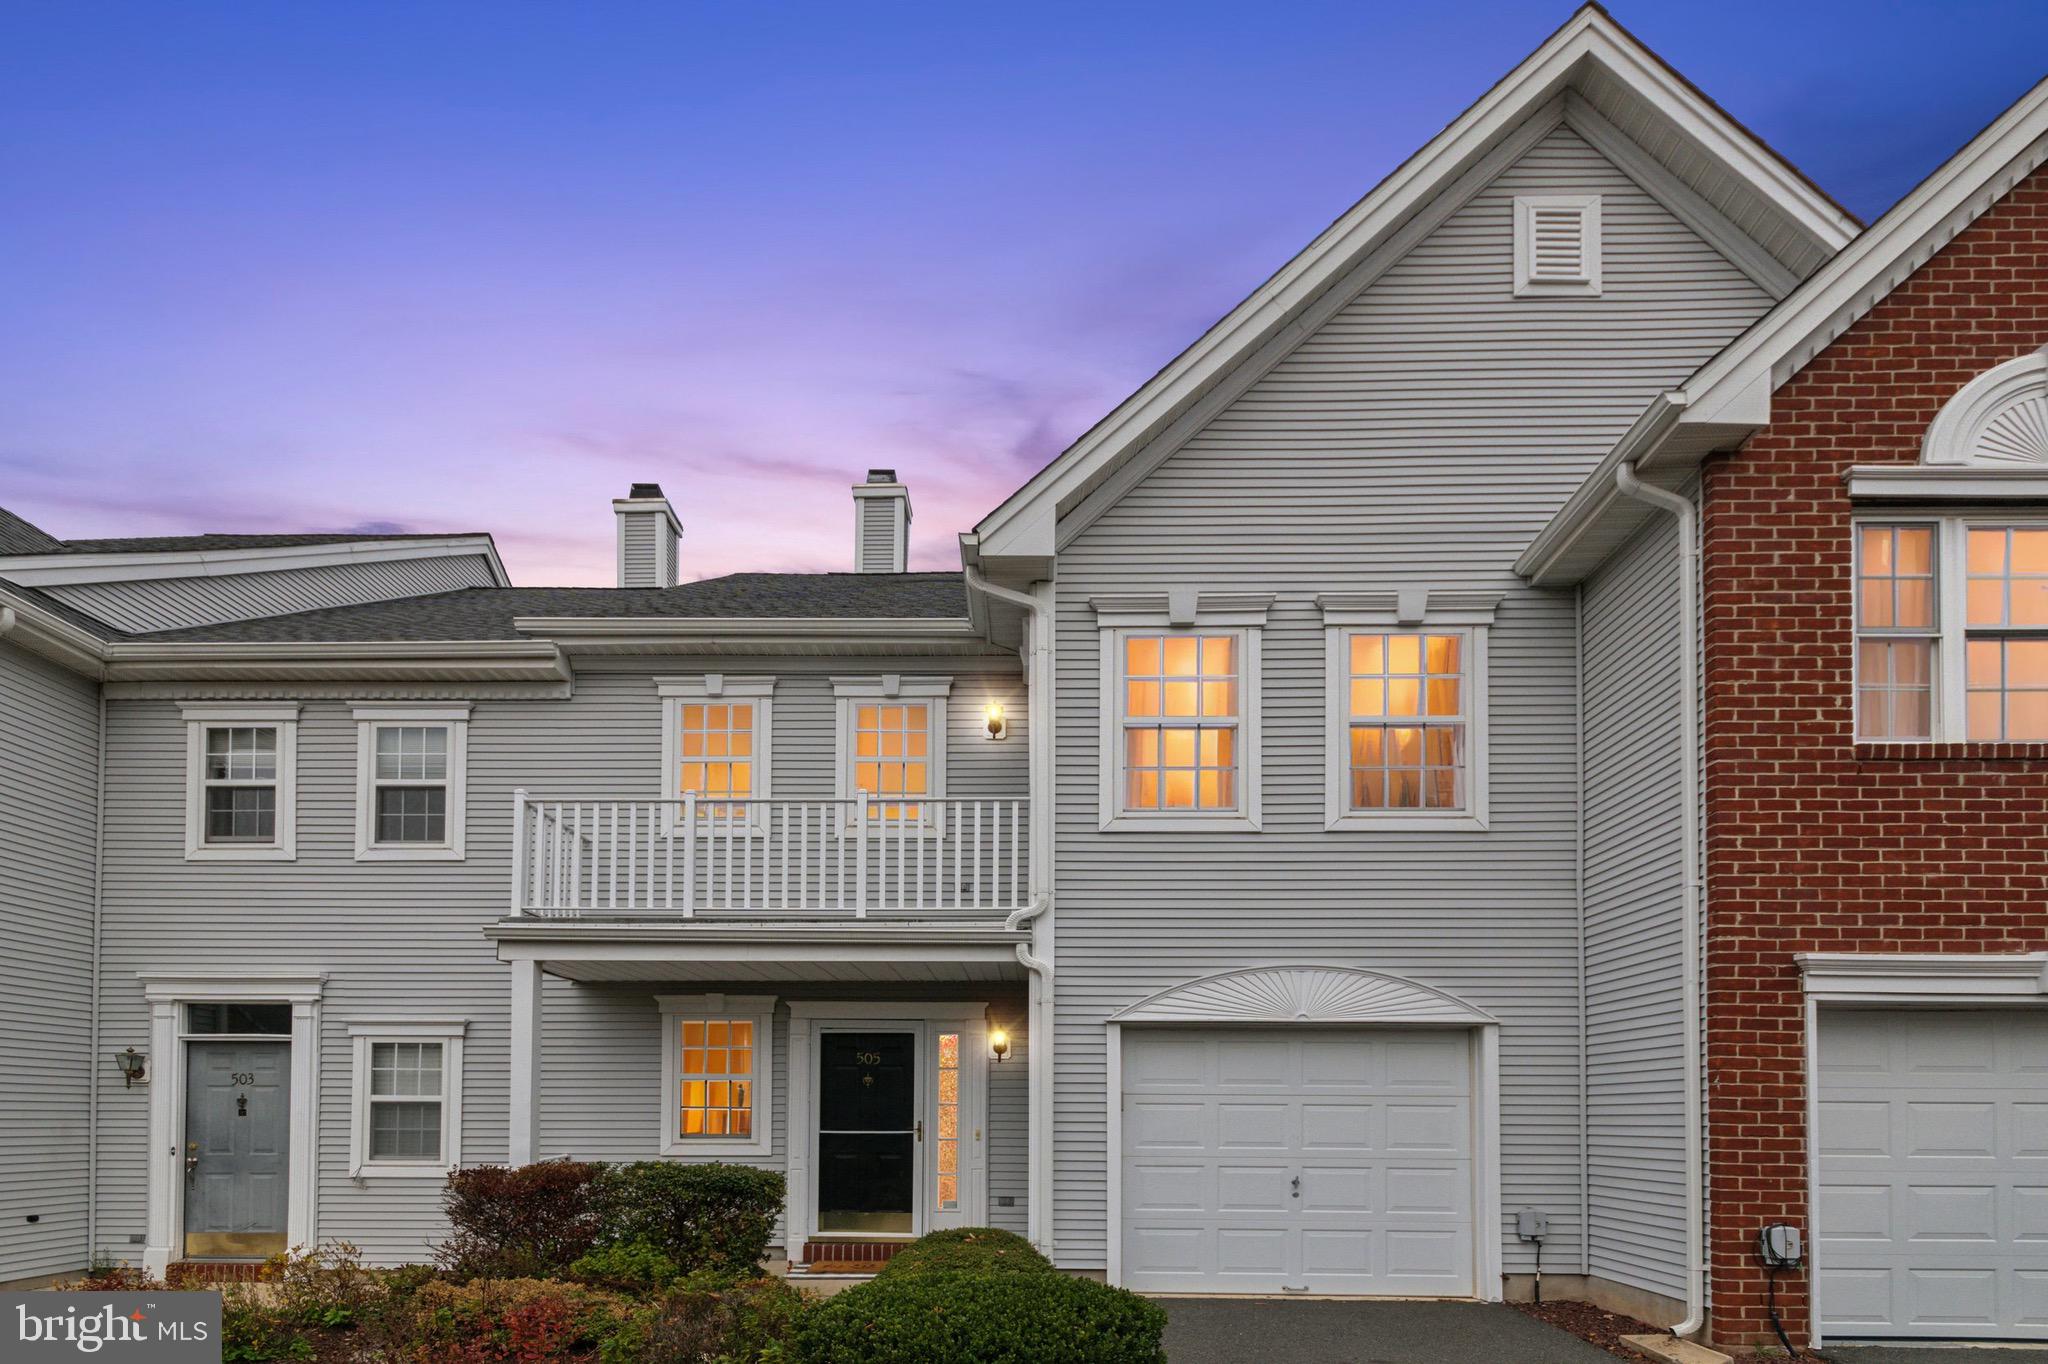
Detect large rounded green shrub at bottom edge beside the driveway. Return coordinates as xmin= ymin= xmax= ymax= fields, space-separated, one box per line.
xmin=797 ymin=1272 xmax=1165 ymax=1364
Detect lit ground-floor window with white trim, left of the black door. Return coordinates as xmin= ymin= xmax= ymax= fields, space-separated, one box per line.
xmin=657 ymin=995 xmax=774 ymax=1155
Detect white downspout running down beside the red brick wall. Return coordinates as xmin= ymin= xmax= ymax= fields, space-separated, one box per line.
xmin=1614 ymin=463 xmax=1706 ymax=1335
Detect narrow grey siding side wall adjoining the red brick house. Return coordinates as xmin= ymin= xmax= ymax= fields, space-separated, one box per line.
xmin=1583 ymin=516 xmax=1686 ymax=1298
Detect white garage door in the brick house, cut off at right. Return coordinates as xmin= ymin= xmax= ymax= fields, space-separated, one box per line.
xmin=1815 ymin=1010 xmax=2048 ymax=1339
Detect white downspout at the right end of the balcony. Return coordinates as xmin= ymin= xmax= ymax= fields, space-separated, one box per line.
xmin=965 ymin=567 xmax=1055 ymax=1260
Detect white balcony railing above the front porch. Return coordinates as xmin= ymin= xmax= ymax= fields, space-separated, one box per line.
xmin=512 ymin=791 xmax=1030 ymax=920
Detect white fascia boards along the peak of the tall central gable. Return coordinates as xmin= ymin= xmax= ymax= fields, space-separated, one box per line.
xmin=975 ymin=6 xmax=1855 ymax=559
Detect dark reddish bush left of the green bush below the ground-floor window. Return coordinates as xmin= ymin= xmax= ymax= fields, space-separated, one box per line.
xmin=436 ymin=1161 xmax=604 ymax=1280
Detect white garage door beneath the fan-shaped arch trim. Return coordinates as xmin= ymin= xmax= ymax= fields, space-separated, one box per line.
xmin=1122 ymin=1028 xmax=1473 ymax=1296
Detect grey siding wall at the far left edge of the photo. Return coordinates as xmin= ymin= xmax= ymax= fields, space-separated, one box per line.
xmin=0 ymin=641 xmax=98 ymax=1284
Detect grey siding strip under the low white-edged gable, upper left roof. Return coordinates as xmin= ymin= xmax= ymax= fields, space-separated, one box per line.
xmin=43 ymin=555 xmax=496 ymax=631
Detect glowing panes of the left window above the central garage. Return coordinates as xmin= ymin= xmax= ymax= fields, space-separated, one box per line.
xmin=1118 ymin=633 xmax=1243 ymax=813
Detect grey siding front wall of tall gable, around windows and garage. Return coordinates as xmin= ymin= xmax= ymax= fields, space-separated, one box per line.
xmin=1055 ymin=129 xmax=1769 ymax=1272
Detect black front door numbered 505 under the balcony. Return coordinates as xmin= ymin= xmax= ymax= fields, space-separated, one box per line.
xmin=817 ymin=1032 xmax=918 ymax=1233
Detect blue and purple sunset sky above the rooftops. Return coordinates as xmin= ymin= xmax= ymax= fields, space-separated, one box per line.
xmin=0 ymin=0 xmax=2048 ymax=584
